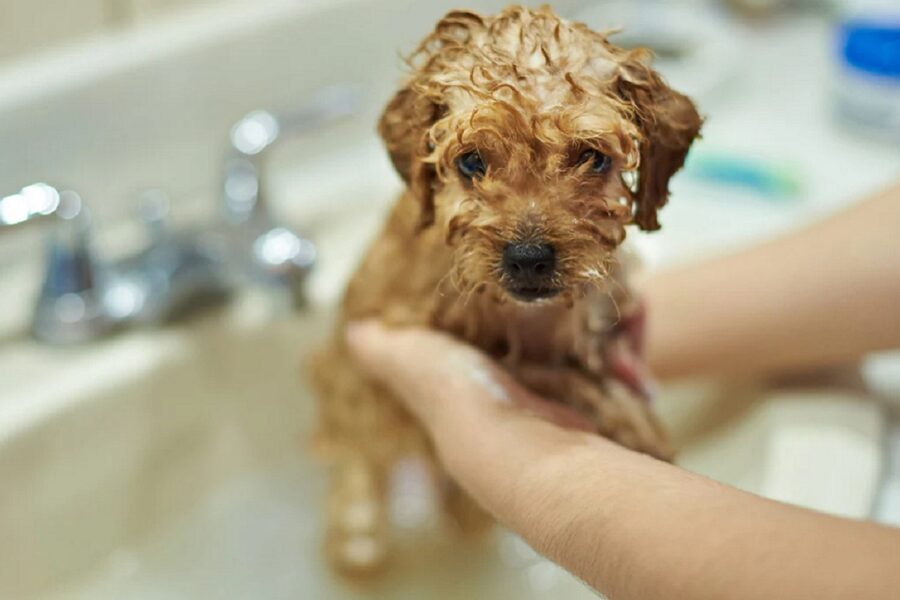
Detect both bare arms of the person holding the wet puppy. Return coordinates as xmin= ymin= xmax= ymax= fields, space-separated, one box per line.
xmin=349 ymin=185 xmax=900 ymax=600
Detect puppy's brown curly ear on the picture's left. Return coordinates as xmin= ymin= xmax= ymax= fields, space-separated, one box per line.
xmin=378 ymin=81 xmax=440 ymax=229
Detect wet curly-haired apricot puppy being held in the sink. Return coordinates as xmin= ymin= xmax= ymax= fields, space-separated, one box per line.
xmin=312 ymin=6 xmax=701 ymax=573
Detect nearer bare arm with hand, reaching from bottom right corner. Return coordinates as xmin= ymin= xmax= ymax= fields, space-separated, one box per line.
xmin=348 ymin=323 xmax=900 ymax=600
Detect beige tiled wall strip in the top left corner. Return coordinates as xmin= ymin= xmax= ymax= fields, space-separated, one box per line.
xmin=0 ymin=0 xmax=229 ymax=63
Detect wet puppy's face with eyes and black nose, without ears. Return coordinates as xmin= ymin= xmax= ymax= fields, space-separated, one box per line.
xmin=426 ymin=93 xmax=638 ymax=301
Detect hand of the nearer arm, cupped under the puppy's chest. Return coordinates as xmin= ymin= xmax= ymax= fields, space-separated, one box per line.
xmin=347 ymin=322 xmax=596 ymax=500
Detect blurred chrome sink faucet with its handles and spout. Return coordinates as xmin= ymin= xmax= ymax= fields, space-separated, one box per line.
xmin=0 ymin=88 xmax=358 ymax=344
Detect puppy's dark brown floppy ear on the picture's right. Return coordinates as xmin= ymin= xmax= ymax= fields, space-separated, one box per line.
xmin=616 ymin=51 xmax=703 ymax=231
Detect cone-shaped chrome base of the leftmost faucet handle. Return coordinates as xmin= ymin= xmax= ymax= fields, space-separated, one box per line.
xmin=32 ymin=191 xmax=113 ymax=344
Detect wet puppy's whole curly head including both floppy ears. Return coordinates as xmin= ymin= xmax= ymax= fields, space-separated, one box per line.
xmin=380 ymin=7 xmax=700 ymax=301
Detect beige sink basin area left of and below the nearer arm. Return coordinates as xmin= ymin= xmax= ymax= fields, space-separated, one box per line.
xmin=0 ymin=232 xmax=593 ymax=599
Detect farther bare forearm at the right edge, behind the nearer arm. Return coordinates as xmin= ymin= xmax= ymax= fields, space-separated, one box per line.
xmin=644 ymin=184 xmax=900 ymax=379
